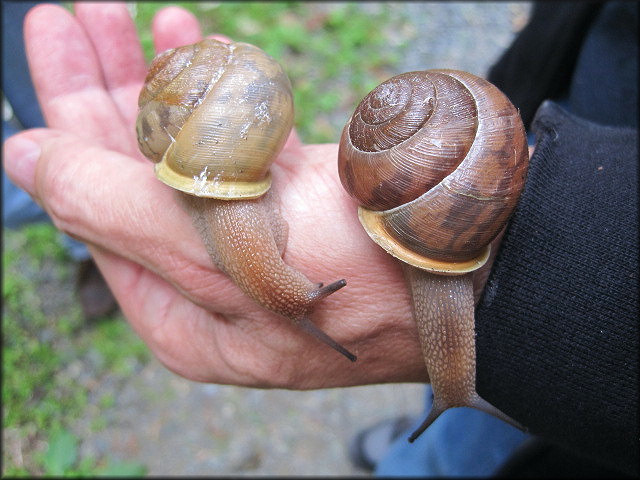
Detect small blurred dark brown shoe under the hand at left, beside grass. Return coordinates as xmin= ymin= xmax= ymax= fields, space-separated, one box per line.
xmin=76 ymin=259 xmax=118 ymax=320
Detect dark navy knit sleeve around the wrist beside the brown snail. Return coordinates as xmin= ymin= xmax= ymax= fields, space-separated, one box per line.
xmin=476 ymin=102 xmax=640 ymax=475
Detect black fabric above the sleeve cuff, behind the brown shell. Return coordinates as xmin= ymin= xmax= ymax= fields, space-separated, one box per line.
xmin=487 ymin=1 xmax=602 ymax=130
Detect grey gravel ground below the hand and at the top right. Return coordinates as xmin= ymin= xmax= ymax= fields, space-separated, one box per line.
xmin=12 ymin=3 xmax=529 ymax=476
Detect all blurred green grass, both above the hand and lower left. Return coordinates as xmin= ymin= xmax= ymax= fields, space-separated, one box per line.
xmin=2 ymin=2 xmax=398 ymax=476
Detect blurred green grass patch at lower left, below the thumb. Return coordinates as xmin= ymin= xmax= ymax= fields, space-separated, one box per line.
xmin=2 ymin=224 xmax=149 ymax=476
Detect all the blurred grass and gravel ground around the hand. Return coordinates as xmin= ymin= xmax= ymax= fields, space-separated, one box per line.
xmin=2 ymin=2 xmax=530 ymax=476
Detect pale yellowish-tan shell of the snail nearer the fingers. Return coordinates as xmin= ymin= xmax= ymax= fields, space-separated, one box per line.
xmin=136 ymin=39 xmax=294 ymax=199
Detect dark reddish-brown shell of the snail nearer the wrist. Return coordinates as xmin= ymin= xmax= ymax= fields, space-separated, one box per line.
xmin=338 ymin=70 xmax=528 ymax=274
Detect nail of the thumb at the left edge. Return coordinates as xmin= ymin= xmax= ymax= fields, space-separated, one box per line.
xmin=4 ymin=135 xmax=41 ymax=195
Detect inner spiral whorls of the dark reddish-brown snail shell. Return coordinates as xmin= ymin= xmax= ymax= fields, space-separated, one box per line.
xmin=339 ymin=71 xmax=477 ymax=210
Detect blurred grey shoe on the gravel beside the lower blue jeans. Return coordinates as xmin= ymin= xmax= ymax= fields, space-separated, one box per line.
xmin=349 ymin=416 xmax=415 ymax=472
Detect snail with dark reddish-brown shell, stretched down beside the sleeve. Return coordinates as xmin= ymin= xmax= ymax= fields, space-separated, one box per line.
xmin=338 ymin=70 xmax=529 ymax=442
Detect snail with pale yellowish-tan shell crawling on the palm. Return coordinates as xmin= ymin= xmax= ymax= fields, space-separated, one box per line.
xmin=136 ymin=39 xmax=356 ymax=361
